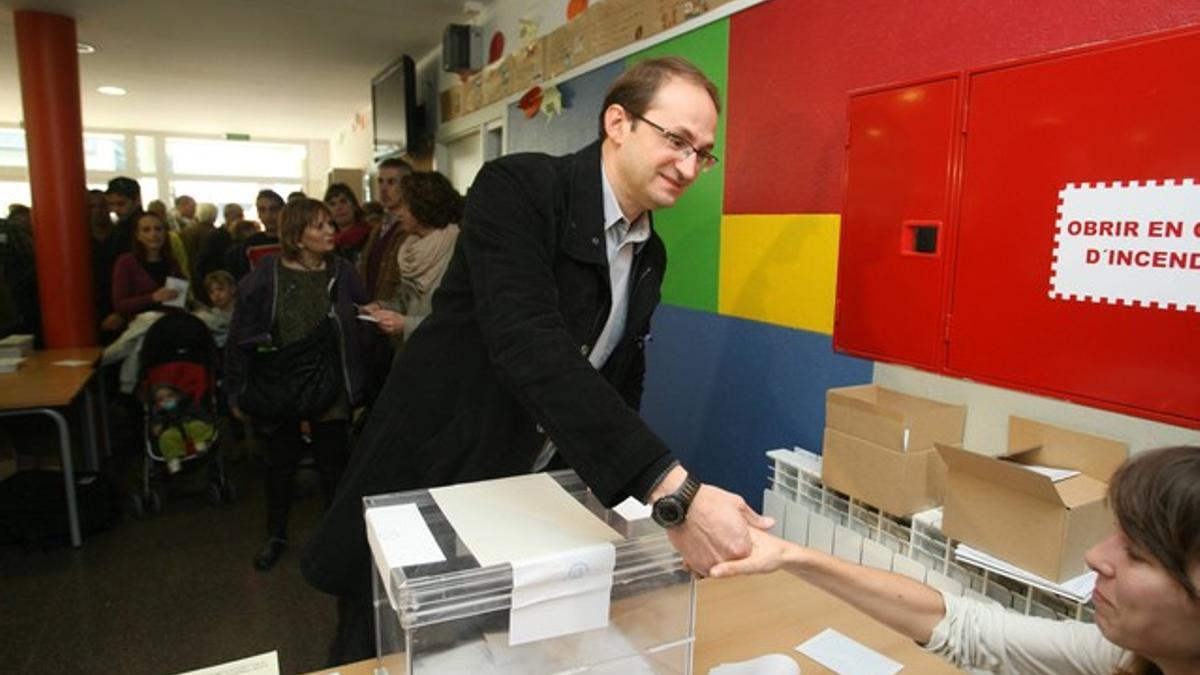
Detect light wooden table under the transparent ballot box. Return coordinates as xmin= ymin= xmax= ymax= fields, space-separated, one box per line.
xmin=319 ymin=572 xmax=961 ymax=675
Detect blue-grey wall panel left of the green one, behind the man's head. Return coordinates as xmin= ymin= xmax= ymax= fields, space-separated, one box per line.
xmin=505 ymin=61 xmax=625 ymax=155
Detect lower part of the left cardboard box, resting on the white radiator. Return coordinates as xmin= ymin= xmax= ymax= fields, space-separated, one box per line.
xmin=821 ymin=428 xmax=946 ymax=515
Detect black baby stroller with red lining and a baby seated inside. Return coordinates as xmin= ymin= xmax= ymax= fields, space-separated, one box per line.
xmin=130 ymin=312 xmax=236 ymax=518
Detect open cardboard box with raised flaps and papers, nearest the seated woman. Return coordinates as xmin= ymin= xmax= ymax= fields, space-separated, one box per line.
xmin=937 ymin=417 xmax=1129 ymax=581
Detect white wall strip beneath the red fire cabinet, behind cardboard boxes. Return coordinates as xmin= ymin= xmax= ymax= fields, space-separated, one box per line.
xmin=874 ymin=363 xmax=1200 ymax=454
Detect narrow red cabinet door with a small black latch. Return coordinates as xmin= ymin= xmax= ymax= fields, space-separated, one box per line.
xmin=833 ymin=77 xmax=960 ymax=370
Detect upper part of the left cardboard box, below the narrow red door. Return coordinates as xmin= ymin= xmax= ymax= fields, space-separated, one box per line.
xmin=826 ymin=384 xmax=967 ymax=452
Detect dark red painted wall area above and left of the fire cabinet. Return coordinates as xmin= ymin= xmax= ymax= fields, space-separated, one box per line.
xmin=722 ymin=0 xmax=1200 ymax=214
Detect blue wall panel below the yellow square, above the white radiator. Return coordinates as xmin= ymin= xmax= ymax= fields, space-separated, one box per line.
xmin=642 ymin=305 xmax=871 ymax=509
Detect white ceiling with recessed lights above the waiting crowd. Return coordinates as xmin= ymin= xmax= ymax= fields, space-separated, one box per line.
xmin=0 ymin=0 xmax=485 ymax=139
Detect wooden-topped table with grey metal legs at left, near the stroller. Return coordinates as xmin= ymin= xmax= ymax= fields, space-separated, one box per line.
xmin=0 ymin=347 xmax=108 ymax=546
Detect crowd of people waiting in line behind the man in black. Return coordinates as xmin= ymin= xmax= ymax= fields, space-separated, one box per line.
xmin=0 ymin=159 xmax=463 ymax=571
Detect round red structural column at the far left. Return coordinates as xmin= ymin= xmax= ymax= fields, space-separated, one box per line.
xmin=13 ymin=11 xmax=97 ymax=348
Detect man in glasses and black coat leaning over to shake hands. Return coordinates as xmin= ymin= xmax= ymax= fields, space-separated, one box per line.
xmin=304 ymin=59 xmax=770 ymax=662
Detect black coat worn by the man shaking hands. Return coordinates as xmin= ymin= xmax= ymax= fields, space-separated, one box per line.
xmin=304 ymin=142 xmax=672 ymax=595
